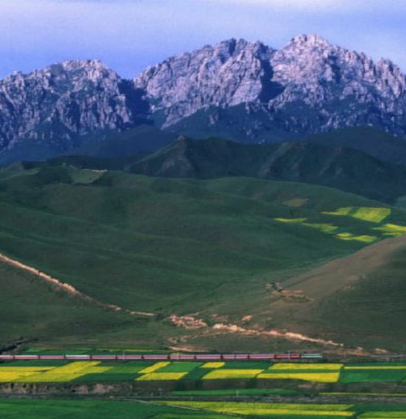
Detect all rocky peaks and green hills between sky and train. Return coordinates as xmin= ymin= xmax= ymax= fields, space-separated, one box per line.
xmin=0 ymin=35 xmax=406 ymax=356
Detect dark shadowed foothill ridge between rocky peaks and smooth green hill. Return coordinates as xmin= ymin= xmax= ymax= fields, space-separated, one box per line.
xmin=130 ymin=137 xmax=406 ymax=202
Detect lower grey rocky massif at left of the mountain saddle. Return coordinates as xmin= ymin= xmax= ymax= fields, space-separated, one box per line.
xmin=0 ymin=61 xmax=140 ymax=148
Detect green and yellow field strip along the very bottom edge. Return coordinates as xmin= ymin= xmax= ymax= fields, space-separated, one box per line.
xmin=0 ymin=399 xmax=406 ymax=419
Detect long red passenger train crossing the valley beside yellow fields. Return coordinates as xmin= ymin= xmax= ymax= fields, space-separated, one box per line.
xmin=0 ymin=353 xmax=323 ymax=362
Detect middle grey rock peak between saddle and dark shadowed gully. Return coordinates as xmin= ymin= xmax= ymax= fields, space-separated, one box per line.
xmin=135 ymin=40 xmax=273 ymax=126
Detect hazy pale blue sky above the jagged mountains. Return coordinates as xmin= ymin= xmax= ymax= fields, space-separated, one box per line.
xmin=0 ymin=0 xmax=406 ymax=77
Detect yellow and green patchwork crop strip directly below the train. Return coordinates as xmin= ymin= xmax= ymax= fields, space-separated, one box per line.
xmin=0 ymin=361 xmax=406 ymax=384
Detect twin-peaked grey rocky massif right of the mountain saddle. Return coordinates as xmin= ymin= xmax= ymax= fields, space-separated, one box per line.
xmin=135 ymin=35 xmax=406 ymax=135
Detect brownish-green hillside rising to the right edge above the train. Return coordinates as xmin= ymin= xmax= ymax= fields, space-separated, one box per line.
xmin=254 ymin=236 xmax=406 ymax=353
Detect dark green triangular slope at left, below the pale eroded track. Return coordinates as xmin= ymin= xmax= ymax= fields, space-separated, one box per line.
xmin=0 ymin=263 xmax=174 ymax=348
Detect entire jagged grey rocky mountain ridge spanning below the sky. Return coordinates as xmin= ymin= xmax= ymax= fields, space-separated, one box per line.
xmin=0 ymin=35 xmax=406 ymax=159
